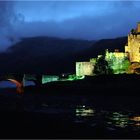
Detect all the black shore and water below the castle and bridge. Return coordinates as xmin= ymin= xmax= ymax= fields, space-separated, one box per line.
xmin=0 ymin=75 xmax=140 ymax=138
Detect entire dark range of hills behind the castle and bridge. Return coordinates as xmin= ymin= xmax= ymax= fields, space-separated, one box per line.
xmin=0 ymin=37 xmax=127 ymax=74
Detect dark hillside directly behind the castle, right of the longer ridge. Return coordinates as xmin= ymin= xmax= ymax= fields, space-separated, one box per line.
xmin=77 ymin=37 xmax=127 ymax=61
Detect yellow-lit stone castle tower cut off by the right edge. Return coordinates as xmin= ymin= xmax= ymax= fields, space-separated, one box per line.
xmin=125 ymin=22 xmax=140 ymax=62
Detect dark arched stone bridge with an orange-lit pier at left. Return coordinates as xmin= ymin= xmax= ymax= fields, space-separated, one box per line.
xmin=0 ymin=73 xmax=42 ymax=94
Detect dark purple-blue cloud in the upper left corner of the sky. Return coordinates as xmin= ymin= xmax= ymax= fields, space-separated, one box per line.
xmin=0 ymin=1 xmax=18 ymax=51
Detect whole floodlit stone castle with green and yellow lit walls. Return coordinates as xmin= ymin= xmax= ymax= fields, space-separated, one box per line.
xmin=76 ymin=22 xmax=140 ymax=76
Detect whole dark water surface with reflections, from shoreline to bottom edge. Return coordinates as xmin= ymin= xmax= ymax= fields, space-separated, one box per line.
xmin=0 ymin=95 xmax=140 ymax=138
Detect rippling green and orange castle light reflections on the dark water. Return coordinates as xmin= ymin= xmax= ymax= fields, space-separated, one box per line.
xmin=33 ymin=104 xmax=140 ymax=131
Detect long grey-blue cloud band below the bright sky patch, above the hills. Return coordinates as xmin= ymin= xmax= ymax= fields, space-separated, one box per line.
xmin=12 ymin=2 xmax=140 ymax=40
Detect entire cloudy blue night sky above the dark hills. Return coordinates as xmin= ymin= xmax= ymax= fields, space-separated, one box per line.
xmin=0 ymin=0 xmax=140 ymax=50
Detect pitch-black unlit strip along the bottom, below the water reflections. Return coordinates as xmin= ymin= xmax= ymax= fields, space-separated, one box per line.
xmin=0 ymin=109 xmax=140 ymax=138
